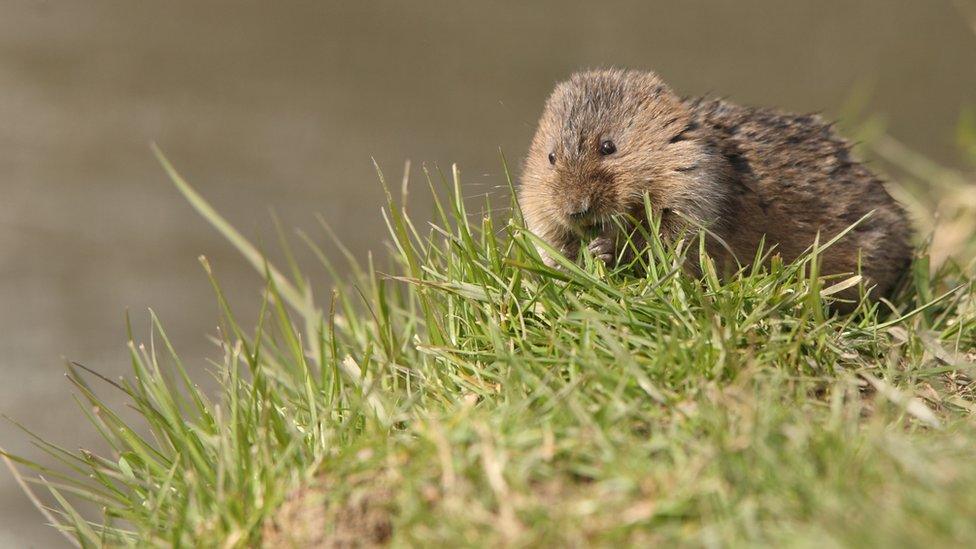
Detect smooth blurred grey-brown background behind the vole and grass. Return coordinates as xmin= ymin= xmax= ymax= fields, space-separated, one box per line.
xmin=0 ymin=0 xmax=976 ymax=547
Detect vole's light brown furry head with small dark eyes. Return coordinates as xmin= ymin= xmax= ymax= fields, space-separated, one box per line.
xmin=520 ymin=70 xmax=719 ymax=238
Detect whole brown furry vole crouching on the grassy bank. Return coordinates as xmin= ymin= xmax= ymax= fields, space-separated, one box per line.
xmin=520 ymin=70 xmax=911 ymax=295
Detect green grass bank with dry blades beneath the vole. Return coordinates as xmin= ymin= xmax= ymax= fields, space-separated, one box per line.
xmin=1 ymin=136 xmax=976 ymax=547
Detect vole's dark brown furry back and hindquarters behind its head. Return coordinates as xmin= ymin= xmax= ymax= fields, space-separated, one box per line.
xmin=688 ymin=99 xmax=911 ymax=295
